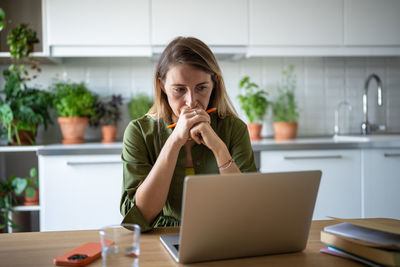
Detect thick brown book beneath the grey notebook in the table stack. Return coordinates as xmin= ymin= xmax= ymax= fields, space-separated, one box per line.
xmin=321 ymin=231 xmax=400 ymax=266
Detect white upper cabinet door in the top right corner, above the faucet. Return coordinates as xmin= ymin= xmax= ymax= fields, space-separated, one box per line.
xmin=344 ymin=0 xmax=400 ymax=46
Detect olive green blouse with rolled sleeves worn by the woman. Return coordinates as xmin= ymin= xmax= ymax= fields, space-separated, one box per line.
xmin=120 ymin=114 xmax=256 ymax=232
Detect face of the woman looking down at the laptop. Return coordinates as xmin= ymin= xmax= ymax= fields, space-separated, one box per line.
xmin=161 ymin=64 xmax=214 ymax=122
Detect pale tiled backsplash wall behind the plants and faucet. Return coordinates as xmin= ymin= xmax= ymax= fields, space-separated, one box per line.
xmin=0 ymin=57 xmax=400 ymax=143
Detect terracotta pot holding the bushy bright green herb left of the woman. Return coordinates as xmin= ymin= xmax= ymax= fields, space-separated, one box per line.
xmin=58 ymin=117 xmax=89 ymax=144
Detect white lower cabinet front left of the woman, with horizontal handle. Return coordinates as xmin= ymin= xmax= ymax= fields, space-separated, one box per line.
xmin=39 ymin=154 xmax=122 ymax=231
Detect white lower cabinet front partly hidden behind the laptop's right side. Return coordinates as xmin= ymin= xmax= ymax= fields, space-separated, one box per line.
xmin=261 ymin=150 xmax=361 ymax=220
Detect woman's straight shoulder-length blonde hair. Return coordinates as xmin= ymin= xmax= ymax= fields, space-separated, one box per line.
xmin=148 ymin=37 xmax=237 ymax=121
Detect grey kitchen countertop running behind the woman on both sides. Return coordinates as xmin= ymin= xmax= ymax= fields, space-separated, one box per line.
xmin=0 ymin=134 xmax=400 ymax=155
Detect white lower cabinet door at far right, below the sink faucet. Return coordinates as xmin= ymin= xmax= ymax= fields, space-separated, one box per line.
xmin=362 ymin=149 xmax=400 ymax=219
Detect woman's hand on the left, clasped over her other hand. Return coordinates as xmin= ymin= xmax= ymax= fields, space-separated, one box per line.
xmin=171 ymin=107 xmax=210 ymax=146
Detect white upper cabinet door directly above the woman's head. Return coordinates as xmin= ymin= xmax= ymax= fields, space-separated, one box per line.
xmin=151 ymin=0 xmax=248 ymax=45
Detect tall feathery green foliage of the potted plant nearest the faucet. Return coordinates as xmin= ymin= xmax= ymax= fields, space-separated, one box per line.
xmin=272 ymin=65 xmax=299 ymax=122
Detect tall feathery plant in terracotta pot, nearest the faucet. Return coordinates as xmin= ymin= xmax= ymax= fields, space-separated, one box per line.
xmin=272 ymin=65 xmax=299 ymax=140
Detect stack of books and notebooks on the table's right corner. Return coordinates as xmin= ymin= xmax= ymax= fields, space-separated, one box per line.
xmin=321 ymin=218 xmax=400 ymax=266
